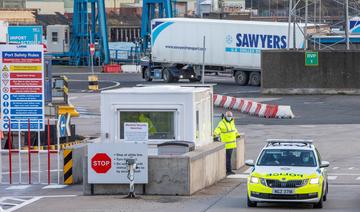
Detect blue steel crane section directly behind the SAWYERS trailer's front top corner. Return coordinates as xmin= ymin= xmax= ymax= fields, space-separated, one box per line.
xmin=141 ymin=0 xmax=175 ymax=51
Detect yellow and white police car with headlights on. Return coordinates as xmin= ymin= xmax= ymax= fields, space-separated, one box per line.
xmin=245 ymin=139 xmax=329 ymax=208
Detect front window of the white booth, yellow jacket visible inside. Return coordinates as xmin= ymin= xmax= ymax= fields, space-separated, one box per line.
xmin=120 ymin=111 xmax=175 ymax=140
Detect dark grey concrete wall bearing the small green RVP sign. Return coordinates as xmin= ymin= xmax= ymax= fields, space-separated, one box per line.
xmin=261 ymin=50 xmax=360 ymax=94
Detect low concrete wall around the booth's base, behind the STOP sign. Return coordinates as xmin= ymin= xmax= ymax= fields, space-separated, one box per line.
xmin=83 ymin=142 xmax=226 ymax=195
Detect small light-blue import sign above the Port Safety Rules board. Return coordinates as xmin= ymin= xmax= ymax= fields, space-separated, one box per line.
xmin=8 ymin=26 xmax=43 ymax=44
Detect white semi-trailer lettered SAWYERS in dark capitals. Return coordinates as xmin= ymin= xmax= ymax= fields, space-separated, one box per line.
xmin=142 ymin=18 xmax=304 ymax=86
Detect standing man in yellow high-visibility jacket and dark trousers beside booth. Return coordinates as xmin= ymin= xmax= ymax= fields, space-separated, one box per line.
xmin=214 ymin=111 xmax=240 ymax=175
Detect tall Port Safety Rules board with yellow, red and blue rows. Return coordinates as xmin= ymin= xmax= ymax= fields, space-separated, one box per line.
xmin=0 ymin=44 xmax=45 ymax=131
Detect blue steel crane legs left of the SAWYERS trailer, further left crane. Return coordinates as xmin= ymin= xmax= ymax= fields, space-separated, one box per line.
xmin=69 ymin=0 xmax=110 ymax=66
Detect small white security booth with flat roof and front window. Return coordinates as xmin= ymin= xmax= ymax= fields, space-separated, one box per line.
xmin=101 ymin=85 xmax=213 ymax=150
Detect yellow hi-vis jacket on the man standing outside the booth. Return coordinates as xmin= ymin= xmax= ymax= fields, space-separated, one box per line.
xmin=214 ymin=118 xmax=240 ymax=149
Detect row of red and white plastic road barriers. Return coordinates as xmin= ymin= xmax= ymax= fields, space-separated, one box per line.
xmin=213 ymin=94 xmax=295 ymax=119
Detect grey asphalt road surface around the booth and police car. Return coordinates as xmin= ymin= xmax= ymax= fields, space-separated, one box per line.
xmin=0 ymin=67 xmax=360 ymax=211
